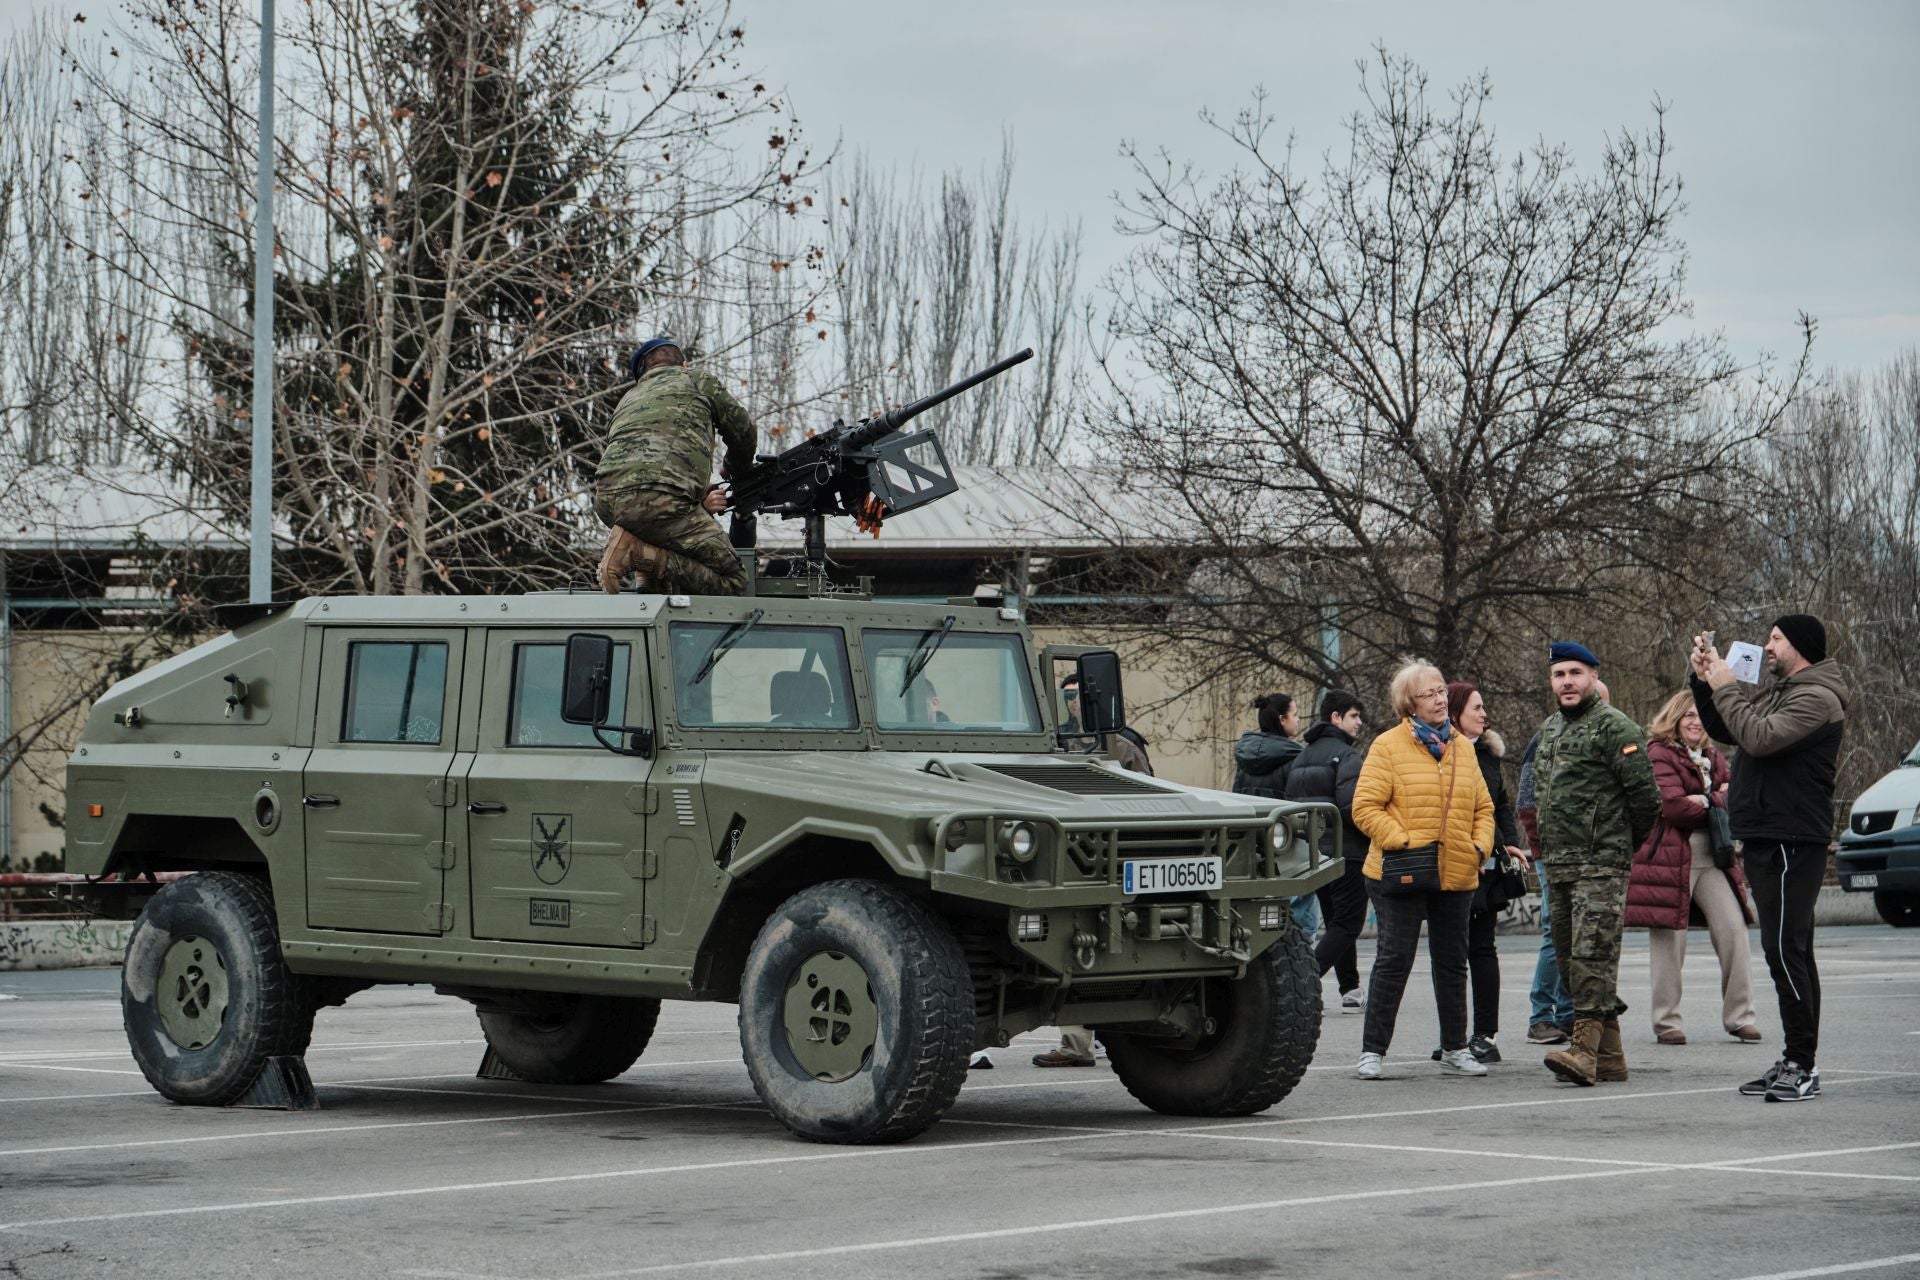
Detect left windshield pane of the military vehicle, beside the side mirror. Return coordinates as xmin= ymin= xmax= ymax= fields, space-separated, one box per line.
xmin=670 ymin=622 xmax=856 ymax=729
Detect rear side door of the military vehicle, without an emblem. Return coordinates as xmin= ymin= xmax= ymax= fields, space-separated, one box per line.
xmin=301 ymin=628 xmax=467 ymax=933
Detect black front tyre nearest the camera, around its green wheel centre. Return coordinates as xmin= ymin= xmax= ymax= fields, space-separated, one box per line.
xmin=739 ymin=879 xmax=973 ymax=1144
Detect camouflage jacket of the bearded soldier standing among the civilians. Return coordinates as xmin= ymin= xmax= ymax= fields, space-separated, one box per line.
xmin=1534 ymin=697 xmax=1661 ymax=867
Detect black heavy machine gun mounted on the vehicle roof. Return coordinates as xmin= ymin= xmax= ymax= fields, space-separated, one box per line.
xmin=728 ymin=347 xmax=1033 ymax=578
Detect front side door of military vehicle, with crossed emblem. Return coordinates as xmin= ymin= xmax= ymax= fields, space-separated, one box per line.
xmin=467 ymin=628 xmax=657 ymax=946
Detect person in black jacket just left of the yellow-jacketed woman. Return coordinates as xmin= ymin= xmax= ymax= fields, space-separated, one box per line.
xmin=1282 ymin=689 xmax=1367 ymax=1013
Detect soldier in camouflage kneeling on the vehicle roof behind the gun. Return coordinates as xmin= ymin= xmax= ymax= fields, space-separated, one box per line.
xmin=593 ymin=338 xmax=758 ymax=595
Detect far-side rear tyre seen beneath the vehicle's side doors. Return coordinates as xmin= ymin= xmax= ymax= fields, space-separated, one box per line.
xmin=478 ymin=996 xmax=660 ymax=1084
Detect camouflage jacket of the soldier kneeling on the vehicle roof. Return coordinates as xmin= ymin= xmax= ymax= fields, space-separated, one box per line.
xmin=593 ymin=365 xmax=758 ymax=503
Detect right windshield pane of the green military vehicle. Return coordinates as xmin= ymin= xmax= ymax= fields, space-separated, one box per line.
xmin=860 ymin=631 xmax=1041 ymax=733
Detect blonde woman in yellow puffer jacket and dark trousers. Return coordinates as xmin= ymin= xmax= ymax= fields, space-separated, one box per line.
xmin=1354 ymin=662 xmax=1494 ymax=1080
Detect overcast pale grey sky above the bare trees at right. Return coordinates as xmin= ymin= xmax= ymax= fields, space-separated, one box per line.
xmin=729 ymin=0 xmax=1920 ymax=378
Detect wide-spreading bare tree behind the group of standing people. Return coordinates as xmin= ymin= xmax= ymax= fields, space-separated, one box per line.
xmin=1085 ymin=50 xmax=1811 ymax=710
